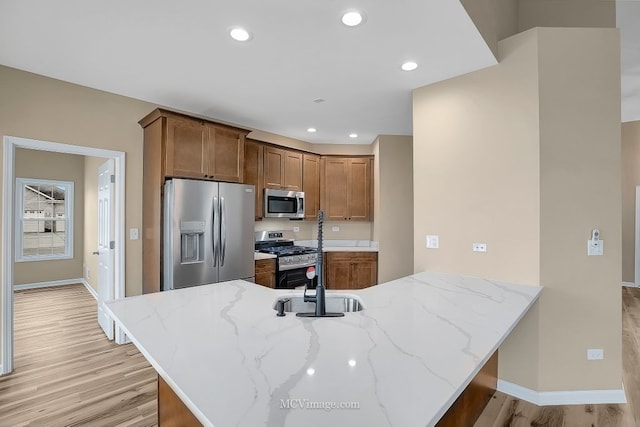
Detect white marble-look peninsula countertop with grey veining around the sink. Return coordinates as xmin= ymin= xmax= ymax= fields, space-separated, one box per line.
xmin=106 ymin=272 xmax=542 ymax=426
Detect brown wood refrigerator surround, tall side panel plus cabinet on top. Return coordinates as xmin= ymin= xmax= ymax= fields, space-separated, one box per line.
xmin=139 ymin=108 xmax=249 ymax=293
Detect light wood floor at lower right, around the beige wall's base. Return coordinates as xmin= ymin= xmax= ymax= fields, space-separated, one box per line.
xmin=475 ymin=287 xmax=640 ymax=427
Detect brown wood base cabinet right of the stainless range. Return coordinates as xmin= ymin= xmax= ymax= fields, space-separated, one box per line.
xmin=324 ymin=252 xmax=378 ymax=289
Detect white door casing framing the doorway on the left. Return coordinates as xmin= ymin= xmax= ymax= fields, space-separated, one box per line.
xmin=0 ymin=136 xmax=125 ymax=375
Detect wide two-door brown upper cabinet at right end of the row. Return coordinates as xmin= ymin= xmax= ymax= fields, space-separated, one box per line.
xmin=320 ymin=156 xmax=373 ymax=221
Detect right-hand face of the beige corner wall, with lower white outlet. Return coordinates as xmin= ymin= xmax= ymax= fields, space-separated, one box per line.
xmin=538 ymin=29 xmax=622 ymax=390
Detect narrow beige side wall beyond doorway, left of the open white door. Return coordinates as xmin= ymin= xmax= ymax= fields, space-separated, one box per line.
xmin=82 ymin=156 xmax=106 ymax=292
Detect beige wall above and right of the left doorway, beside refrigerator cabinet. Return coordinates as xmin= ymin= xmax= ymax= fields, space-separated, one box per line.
xmin=0 ymin=66 xmax=155 ymax=302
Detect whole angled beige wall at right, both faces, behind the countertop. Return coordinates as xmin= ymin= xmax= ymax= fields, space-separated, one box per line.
xmin=414 ymin=28 xmax=621 ymax=391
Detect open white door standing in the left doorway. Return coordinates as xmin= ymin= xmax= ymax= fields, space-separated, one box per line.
xmin=94 ymin=159 xmax=115 ymax=340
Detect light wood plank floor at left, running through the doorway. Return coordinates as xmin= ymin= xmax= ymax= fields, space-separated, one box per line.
xmin=0 ymin=285 xmax=157 ymax=426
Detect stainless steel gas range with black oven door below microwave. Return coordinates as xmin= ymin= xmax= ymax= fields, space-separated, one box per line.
xmin=256 ymin=231 xmax=318 ymax=289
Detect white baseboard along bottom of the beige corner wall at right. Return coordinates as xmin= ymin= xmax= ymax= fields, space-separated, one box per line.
xmin=497 ymin=379 xmax=627 ymax=406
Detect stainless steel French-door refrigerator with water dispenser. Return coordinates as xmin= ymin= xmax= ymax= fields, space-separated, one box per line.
xmin=162 ymin=179 xmax=255 ymax=291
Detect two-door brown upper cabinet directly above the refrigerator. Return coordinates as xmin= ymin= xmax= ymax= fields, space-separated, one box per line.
xmin=140 ymin=109 xmax=248 ymax=182
